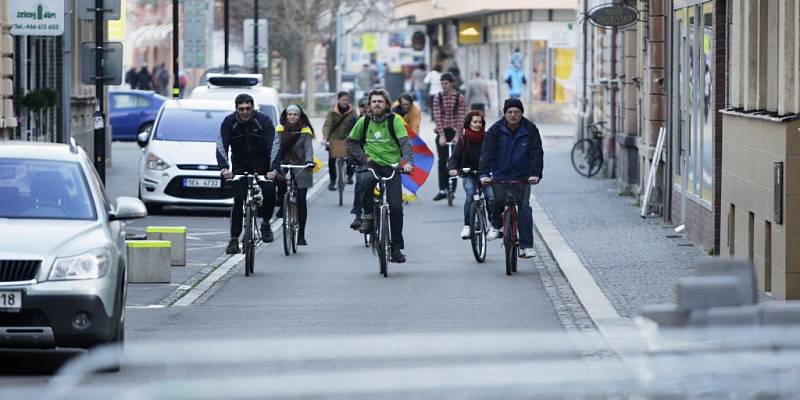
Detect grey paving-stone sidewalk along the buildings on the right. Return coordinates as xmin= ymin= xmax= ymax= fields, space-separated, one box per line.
xmin=534 ymin=137 xmax=709 ymax=317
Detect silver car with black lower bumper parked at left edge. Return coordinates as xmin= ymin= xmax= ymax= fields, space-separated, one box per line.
xmin=0 ymin=141 xmax=147 ymax=348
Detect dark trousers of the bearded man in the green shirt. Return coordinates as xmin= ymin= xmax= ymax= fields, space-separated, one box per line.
xmin=360 ymin=166 xmax=404 ymax=249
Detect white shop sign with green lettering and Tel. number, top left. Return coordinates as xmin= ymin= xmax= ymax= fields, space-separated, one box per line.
xmin=7 ymin=0 xmax=64 ymax=36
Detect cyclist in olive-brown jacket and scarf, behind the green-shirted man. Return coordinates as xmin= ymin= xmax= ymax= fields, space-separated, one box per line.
xmin=322 ymin=91 xmax=356 ymax=190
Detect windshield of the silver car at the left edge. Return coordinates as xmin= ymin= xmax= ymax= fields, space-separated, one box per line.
xmin=0 ymin=158 xmax=97 ymax=220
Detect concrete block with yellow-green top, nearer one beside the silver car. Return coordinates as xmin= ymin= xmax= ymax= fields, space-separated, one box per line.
xmin=127 ymin=240 xmax=172 ymax=283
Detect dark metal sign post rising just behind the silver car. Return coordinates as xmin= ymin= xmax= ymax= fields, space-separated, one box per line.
xmin=94 ymin=0 xmax=106 ymax=183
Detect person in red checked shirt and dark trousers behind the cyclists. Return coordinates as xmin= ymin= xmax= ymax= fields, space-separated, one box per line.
xmin=433 ymin=72 xmax=467 ymax=201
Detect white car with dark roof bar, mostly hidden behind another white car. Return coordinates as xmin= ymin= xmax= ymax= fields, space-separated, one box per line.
xmin=189 ymin=73 xmax=282 ymax=126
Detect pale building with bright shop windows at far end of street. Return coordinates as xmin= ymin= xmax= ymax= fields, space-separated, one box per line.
xmin=394 ymin=0 xmax=577 ymax=121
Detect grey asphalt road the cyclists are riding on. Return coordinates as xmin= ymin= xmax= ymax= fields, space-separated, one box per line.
xmin=0 ymin=119 xmax=580 ymax=398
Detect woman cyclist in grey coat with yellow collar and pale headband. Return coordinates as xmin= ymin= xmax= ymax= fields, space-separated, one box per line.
xmin=264 ymin=104 xmax=314 ymax=246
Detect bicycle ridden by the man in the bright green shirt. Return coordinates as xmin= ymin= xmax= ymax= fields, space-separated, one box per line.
xmin=366 ymin=164 xmax=398 ymax=278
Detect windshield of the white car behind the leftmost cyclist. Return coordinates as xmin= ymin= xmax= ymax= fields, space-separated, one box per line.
xmin=155 ymin=109 xmax=233 ymax=142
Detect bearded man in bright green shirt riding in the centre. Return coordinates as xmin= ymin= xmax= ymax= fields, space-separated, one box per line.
xmin=347 ymin=89 xmax=413 ymax=263
